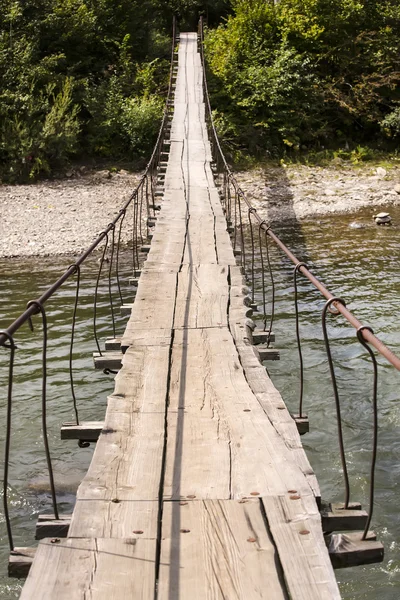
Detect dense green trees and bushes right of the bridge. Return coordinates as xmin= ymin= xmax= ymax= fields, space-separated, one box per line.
xmin=207 ymin=0 xmax=400 ymax=155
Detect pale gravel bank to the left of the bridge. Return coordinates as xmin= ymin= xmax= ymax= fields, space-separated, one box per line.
xmin=0 ymin=171 xmax=140 ymax=257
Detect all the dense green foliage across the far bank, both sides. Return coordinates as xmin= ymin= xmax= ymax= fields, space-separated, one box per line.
xmin=0 ymin=0 xmax=400 ymax=181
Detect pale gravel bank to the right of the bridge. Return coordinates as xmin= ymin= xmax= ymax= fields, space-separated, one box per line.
xmin=237 ymin=164 xmax=400 ymax=221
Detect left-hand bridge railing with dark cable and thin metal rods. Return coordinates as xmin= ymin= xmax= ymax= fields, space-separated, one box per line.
xmin=0 ymin=17 xmax=179 ymax=551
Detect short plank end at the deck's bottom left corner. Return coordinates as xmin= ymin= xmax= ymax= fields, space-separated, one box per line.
xmin=20 ymin=537 xmax=156 ymax=600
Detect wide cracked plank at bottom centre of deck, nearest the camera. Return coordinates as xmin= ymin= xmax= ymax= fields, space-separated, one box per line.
xmin=158 ymin=500 xmax=288 ymax=600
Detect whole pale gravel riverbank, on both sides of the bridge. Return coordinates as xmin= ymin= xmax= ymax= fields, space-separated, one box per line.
xmin=0 ymin=165 xmax=400 ymax=257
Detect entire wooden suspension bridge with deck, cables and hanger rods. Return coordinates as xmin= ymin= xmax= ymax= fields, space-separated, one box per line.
xmin=0 ymin=19 xmax=400 ymax=600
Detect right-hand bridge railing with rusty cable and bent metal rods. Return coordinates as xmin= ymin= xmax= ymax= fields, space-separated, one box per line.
xmin=198 ymin=18 xmax=400 ymax=540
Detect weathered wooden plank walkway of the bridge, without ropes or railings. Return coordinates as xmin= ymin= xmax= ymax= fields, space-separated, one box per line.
xmin=21 ymin=33 xmax=340 ymax=600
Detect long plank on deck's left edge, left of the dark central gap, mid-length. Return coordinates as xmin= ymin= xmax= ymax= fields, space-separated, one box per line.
xmin=77 ymin=346 xmax=170 ymax=506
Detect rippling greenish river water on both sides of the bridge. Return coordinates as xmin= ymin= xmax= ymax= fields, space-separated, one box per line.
xmin=0 ymin=209 xmax=400 ymax=600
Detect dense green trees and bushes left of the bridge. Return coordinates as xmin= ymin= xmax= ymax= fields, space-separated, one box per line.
xmin=0 ymin=0 xmax=227 ymax=181
